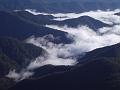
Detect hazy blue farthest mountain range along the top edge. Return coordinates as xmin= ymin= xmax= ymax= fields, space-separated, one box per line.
xmin=0 ymin=0 xmax=120 ymax=13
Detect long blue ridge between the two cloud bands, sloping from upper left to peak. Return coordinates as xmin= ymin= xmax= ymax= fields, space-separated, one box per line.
xmin=13 ymin=11 xmax=110 ymax=30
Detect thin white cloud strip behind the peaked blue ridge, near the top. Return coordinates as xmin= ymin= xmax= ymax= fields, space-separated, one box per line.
xmin=25 ymin=9 xmax=120 ymax=24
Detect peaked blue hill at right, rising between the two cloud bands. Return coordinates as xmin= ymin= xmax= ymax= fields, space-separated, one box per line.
xmin=56 ymin=16 xmax=110 ymax=30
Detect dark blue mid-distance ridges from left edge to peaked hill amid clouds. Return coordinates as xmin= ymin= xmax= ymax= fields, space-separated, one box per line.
xmin=0 ymin=11 xmax=110 ymax=43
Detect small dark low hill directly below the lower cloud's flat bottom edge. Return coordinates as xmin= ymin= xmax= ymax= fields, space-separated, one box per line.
xmin=31 ymin=65 xmax=75 ymax=79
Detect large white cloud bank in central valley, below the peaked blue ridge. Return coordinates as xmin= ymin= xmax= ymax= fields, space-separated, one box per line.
xmin=26 ymin=25 xmax=120 ymax=73
